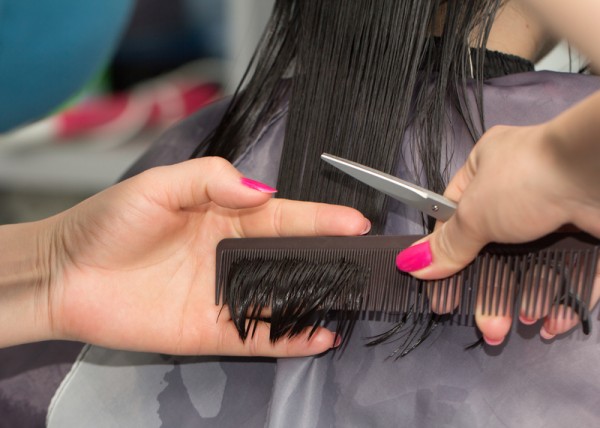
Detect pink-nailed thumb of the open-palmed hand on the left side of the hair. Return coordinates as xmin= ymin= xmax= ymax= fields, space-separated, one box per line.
xmin=129 ymin=157 xmax=276 ymax=211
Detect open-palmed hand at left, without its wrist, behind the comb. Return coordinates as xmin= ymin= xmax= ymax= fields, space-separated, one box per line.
xmin=32 ymin=158 xmax=369 ymax=356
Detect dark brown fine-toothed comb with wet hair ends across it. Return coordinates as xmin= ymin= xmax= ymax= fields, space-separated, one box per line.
xmin=216 ymin=233 xmax=600 ymax=341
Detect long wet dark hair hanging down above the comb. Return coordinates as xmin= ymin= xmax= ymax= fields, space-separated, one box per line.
xmin=193 ymin=0 xmax=500 ymax=233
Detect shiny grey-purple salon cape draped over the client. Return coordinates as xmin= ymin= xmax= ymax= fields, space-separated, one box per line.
xmin=48 ymin=72 xmax=600 ymax=428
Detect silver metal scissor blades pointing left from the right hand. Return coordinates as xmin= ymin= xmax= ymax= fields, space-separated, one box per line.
xmin=321 ymin=153 xmax=456 ymax=221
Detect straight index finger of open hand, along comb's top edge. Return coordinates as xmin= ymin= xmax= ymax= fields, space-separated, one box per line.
xmin=240 ymin=199 xmax=371 ymax=237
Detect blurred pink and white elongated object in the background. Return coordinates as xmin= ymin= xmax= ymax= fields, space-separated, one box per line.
xmin=0 ymin=69 xmax=221 ymax=149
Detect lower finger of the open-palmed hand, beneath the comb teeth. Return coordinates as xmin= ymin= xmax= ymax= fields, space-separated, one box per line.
xmin=215 ymin=322 xmax=341 ymax=357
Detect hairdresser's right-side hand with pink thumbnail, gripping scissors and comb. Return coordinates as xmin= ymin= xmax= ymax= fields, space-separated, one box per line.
xmin=399 ymin=124 xmax=600 ymax=345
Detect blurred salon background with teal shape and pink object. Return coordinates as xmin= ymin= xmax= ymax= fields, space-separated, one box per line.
xmin=0 ymin=0 xmax=583 ymax=224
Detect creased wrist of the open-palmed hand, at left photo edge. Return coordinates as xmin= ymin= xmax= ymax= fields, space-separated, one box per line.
xmin=0 ymin=220 xmax=61 ymax=347
